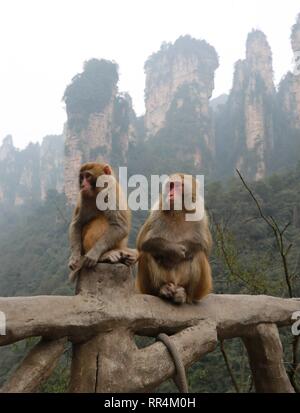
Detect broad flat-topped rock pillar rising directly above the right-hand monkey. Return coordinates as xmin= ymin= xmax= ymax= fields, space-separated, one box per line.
xmin=145 ymin=36 xmax=219 ymax=169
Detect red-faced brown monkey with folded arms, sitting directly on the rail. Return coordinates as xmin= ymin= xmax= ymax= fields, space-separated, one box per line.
xmin=137 ymin=174 xmax=212 ymax=303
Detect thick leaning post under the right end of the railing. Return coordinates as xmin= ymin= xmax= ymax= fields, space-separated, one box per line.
xmin=243 ymin=324 xmax=295 ymax=393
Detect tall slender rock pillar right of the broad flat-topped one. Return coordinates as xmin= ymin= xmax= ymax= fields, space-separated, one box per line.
xmin=216 ymin=30 xmax=276 ymax=180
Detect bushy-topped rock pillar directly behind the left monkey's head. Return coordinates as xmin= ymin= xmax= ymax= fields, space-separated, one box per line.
xmin=64 ymin=59 xmax=135 ymax=204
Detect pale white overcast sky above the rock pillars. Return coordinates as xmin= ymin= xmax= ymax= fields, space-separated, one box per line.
xmin=0 ymin=0 xmax=300 ymax=147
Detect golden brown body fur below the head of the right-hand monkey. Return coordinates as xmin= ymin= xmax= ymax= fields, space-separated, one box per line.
xmin=136 ymin=174 xmax=212 ymax=303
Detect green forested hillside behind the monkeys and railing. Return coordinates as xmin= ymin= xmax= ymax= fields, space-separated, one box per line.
xmin=0 ymin=164 xmax=300 ymax=392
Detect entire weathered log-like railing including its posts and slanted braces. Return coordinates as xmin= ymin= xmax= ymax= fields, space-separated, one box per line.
xmin=0 ymin=264 xmax=300 ymax=392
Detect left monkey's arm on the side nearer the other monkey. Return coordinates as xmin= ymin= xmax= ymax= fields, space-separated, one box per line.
xmin=83 ymin=211 xmax=129 ymax=268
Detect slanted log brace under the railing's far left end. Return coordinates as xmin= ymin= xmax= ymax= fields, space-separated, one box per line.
xmin=0 ymin=339 xmax=67 ymax=393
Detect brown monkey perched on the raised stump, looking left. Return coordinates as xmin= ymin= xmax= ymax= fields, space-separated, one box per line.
xmin=69 ymin=163 xmax=136 ymax=280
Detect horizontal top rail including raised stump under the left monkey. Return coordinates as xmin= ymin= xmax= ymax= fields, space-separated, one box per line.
xmin=0 ymin=264 xmax=300 ymax=345
